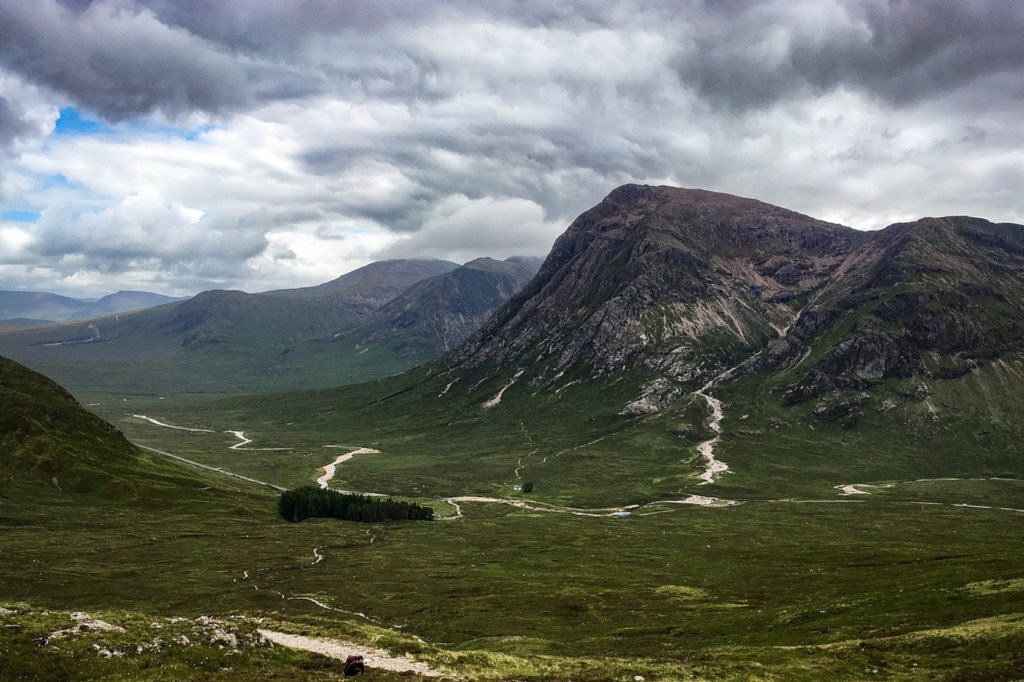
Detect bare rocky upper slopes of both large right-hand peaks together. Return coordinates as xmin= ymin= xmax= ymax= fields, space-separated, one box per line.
xmin=447 ymin=185 xmax=1024 ymax=417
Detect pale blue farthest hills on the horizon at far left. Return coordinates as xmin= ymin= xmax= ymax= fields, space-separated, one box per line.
xmin=0 ymin=291 xmax=183 ymax=327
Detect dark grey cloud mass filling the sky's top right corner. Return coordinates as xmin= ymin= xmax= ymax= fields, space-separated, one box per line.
xmin=677 ymin=0 xmax=1024 ymax=111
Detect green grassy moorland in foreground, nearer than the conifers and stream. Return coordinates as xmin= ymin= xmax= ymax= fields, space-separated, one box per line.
xmin=0 ymin=462 xmax=1024 ymax=680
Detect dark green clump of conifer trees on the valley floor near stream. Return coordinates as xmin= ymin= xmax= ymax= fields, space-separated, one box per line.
xmin=278 ymin=485 xmax=434 ymax=523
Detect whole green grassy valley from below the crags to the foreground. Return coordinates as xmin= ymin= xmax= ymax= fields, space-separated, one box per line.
xmin=4 ymin=342 xmax=1007 ymax=680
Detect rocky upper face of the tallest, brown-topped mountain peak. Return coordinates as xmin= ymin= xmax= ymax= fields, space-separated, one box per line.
xmin=454 ymin=185 xmax=865 ymax=380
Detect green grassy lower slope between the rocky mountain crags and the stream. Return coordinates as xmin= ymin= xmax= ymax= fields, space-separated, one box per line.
xmin=100 ymin=337 xmax=1024 ymax=507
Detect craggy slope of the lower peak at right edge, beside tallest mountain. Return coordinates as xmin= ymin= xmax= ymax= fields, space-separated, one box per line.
xmin=756 ymin=217 xmax=1024 ymax=404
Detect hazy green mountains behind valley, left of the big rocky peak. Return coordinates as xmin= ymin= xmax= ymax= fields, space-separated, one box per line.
xmin=0 ymin=258 xmax=541 ymax=394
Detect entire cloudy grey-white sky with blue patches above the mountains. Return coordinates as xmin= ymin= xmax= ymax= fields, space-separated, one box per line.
xmin=0 ymin=0 xmax=1024 ymax=296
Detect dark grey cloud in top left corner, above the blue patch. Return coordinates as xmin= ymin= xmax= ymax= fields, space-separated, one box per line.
xmin=0 ymin=0 xmax=251 ymax=121
